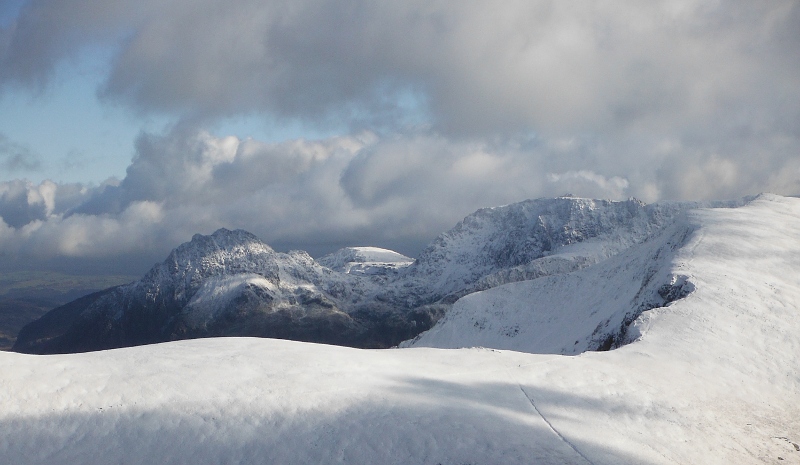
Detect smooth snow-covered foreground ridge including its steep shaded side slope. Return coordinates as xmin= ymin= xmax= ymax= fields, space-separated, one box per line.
xmin=0 ymin=195 xmax=800 ymax=465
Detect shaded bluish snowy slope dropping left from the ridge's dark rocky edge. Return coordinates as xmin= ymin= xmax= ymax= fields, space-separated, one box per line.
xmin=402 ymin=215 xmax=694 ymax=354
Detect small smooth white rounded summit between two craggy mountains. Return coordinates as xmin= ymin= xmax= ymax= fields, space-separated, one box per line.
xmin=317 ymin=247 xmax=414 ymax=275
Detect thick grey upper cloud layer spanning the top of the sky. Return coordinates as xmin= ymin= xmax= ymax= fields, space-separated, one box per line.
xmin=0 ymin=0 xmax=800 ymax=135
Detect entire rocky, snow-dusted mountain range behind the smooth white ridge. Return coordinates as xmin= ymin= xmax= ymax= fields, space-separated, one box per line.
xmin=13 ymin=197 xmax=736 ymax=353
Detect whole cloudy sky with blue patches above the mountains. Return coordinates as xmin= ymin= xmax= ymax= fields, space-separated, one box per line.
xmin=0 ymin=0 xmax=800 ymax=274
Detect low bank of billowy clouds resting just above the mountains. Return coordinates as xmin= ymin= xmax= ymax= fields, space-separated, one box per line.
xmin=0 ymin=126 xmax=800 ymax=273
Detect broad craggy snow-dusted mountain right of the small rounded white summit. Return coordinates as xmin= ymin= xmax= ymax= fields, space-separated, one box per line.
xmin=396 ymin=197 xmax=746 ymax=301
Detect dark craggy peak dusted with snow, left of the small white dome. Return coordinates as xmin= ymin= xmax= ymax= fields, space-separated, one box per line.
xmin=15 ymin=229 xmax=376 ymax=352
